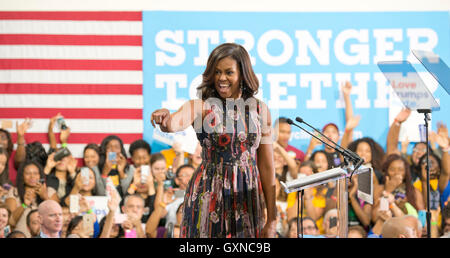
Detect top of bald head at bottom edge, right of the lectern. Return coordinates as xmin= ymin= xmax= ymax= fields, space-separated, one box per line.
xmin=381 ymin=217 xmax=417 ymax=238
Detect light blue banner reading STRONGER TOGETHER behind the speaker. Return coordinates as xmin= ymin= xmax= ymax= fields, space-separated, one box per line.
xmin=143 ymin=11 xmax=450 ymax=151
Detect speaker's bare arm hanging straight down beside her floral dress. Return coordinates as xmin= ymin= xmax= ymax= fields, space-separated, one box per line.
xmin=257 ymin=104 xmax=277 ymax=237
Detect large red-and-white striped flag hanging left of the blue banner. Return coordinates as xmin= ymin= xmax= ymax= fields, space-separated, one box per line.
xmin=0 ymin=12 xmax=143 ymax=163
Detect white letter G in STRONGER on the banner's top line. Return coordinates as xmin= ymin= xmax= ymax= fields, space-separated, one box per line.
xmin=334 ymin=29 xmax=369 ymax=65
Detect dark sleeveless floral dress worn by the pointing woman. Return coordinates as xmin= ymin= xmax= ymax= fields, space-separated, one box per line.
xmin=181 ymin=99 xmax=265 ymax=238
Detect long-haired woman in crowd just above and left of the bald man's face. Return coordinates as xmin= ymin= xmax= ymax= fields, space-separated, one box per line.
xmin=10 ymin=160 xmax=50 ymax=237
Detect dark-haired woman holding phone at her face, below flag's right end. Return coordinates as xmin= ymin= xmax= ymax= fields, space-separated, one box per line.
xmin=99 ymin=135 xmax=134 ymax=197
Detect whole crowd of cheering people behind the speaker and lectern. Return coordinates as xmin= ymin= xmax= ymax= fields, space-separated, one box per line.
xmin=0 ymin=83 xmax=450 ymax=238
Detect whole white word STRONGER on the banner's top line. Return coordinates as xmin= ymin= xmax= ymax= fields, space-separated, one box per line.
xmin=155 ymin=28 xmax=439 ymax=66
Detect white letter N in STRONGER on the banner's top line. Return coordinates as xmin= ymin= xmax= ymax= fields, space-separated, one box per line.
xmin=295 ymin=30 xmax=332 ymax=65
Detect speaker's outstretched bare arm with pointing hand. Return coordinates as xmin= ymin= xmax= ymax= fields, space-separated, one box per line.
xmin=150 ymin=100 xmax=203 ymax=133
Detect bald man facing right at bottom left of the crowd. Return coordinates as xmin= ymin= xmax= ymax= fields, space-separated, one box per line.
xmin=38 ymin=200 xmax=63 ymax=238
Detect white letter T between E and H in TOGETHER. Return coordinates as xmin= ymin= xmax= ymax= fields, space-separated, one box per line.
xmin=300 ymin=73 xmax=331 ymax=109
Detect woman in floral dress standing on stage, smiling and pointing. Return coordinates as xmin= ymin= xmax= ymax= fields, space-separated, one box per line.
xmin=151 ymin=43 xmax=276 ymax=238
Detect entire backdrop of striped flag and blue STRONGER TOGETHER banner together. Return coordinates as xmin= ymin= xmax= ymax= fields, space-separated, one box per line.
xmin=0 ymin=11 xmax=450 ymax=158
